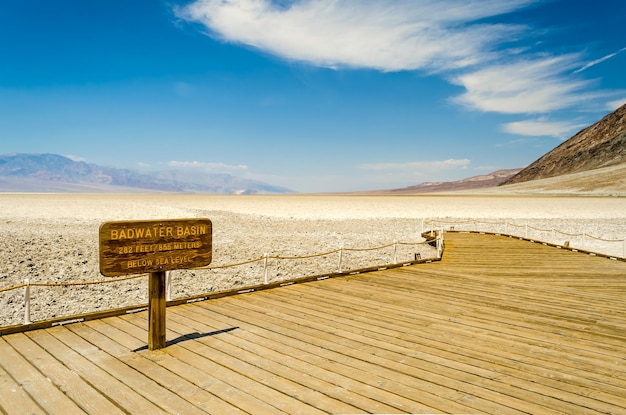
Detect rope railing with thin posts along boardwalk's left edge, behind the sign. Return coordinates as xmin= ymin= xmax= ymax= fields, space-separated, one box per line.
xmin=0 ymin=241 xmax=432 ymax=324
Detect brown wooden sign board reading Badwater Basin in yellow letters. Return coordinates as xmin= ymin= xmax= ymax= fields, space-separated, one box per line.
xmin=100 ymin=218 xmax=213 ymax=277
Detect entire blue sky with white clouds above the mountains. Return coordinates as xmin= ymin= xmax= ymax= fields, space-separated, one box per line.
xmin=0 ymin=0 xmax=626 ymax=192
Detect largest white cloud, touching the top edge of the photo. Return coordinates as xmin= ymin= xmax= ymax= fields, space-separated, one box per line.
xmin=177 ymin=0 xmax=535 ymax=71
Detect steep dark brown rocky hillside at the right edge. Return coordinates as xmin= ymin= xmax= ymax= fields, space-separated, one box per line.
xmin=503 ymin=105 xmax=626 ymax=185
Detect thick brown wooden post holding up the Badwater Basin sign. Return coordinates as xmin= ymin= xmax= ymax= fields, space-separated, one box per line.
xmin=148 ymin=271 xmax=166 ymax=350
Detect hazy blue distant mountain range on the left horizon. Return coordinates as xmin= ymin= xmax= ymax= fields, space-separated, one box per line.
xmin=0 ymin=154 xmax=293 ymax=194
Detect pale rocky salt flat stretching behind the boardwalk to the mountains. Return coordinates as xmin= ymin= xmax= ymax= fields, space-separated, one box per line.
xmin=0 ymin=193 xmax=626 ymax=326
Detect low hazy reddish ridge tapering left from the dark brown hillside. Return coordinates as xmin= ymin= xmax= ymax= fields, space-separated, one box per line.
xmin=358 ymin=169 xmax=521 ymax=195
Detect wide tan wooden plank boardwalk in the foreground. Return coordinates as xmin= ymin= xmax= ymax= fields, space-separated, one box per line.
xmin=0 ymin=233 xmax=626 ymax=415
